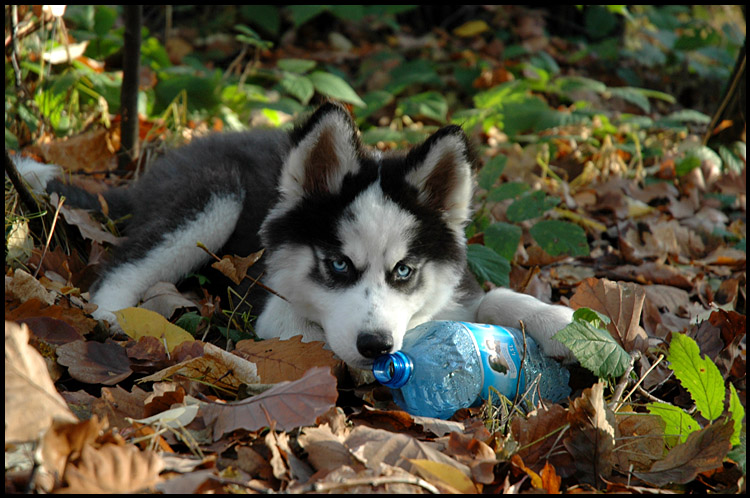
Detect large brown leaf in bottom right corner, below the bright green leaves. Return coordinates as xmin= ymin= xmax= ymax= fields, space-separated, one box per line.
xmin=633 ymin=422 xmax=734 ymax=486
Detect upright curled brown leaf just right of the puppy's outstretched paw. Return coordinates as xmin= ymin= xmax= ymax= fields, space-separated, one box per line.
xmin=570 ymin=278 xmax=648 ymax=351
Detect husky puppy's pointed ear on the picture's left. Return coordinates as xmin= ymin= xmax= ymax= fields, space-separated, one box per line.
xmin=279 ymin=103 xmax=361 ymax=199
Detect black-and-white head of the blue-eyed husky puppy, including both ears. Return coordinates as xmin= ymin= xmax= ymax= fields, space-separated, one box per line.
xmin=261 ymin=104 xmax=472 ymax=367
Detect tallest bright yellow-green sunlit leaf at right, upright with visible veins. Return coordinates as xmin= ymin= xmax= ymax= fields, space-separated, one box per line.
xmin=667 ymin=334 xmax=725 ymax=421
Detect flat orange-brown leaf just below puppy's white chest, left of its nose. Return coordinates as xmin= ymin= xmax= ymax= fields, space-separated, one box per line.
xmin=233 ymin=336 xmax=341 ymax=384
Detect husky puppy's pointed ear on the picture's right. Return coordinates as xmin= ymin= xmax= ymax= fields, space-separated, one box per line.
xmin=406 ymin=125 xmax=474 ymax=226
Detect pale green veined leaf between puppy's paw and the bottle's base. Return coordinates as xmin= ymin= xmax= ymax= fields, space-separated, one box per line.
xmin=552 ymin=320 xmax=630 ymax=379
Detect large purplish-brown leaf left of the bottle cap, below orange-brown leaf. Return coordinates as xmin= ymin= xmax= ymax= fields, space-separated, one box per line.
xmin=201 ymin=367 xmax=338 ymax=441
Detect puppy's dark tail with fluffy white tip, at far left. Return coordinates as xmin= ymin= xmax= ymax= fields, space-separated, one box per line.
xmin=13 ymin=156 xmax=132 ymax=220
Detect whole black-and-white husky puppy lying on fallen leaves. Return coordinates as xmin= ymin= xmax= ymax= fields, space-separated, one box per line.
xmin=19 ymin=104 xmax=572 ymax=368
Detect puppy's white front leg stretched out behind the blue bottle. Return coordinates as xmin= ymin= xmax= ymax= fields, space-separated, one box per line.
xmin=477 ymin=289 xmax=576 ymax=363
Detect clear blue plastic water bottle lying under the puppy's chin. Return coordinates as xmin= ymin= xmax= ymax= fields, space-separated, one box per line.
xmin=372 ymin=321 xmax=570 ymax=418
